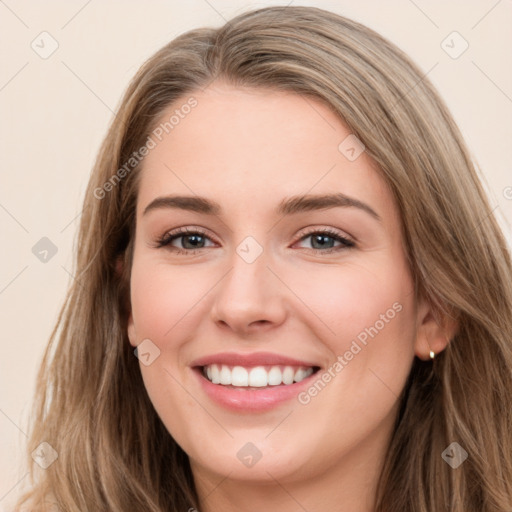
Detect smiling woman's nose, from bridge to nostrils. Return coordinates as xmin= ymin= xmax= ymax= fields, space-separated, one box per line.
xmin=211 ymin=247 xmax=286 ymax=336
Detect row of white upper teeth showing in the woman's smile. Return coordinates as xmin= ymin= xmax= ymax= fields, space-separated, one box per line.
xmin=203 ymin=364 xmax=313 ymax=388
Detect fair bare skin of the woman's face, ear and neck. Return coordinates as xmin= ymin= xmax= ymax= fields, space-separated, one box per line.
xmin=128 ymin=82 xmax=454 ymax=512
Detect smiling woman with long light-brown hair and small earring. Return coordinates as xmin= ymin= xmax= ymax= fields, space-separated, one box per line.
xmin=15 ymin=7 xmax=512 ymax=512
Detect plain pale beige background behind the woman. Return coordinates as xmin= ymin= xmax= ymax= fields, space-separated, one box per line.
xmin=0 ymin=0 xmax=512 ymax=510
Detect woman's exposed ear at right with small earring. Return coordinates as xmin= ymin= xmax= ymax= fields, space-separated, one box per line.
xmin=414 ymin=300 xmax=459 ymax=361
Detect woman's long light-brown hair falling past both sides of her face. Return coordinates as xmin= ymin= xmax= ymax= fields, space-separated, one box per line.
xmin=14 ymin=7 xmax=512 ymax=512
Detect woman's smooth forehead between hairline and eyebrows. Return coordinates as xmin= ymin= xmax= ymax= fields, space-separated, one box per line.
xmin=138 ymin=83 xmax=390 ymax=220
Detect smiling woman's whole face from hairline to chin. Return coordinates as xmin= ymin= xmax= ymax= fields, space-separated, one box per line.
xmin=128 ymin=82 xmax=428 ymax=492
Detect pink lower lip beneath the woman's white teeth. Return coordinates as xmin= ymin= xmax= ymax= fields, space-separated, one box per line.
xmin=193 ymin=368 xmax=318 ymax=412
